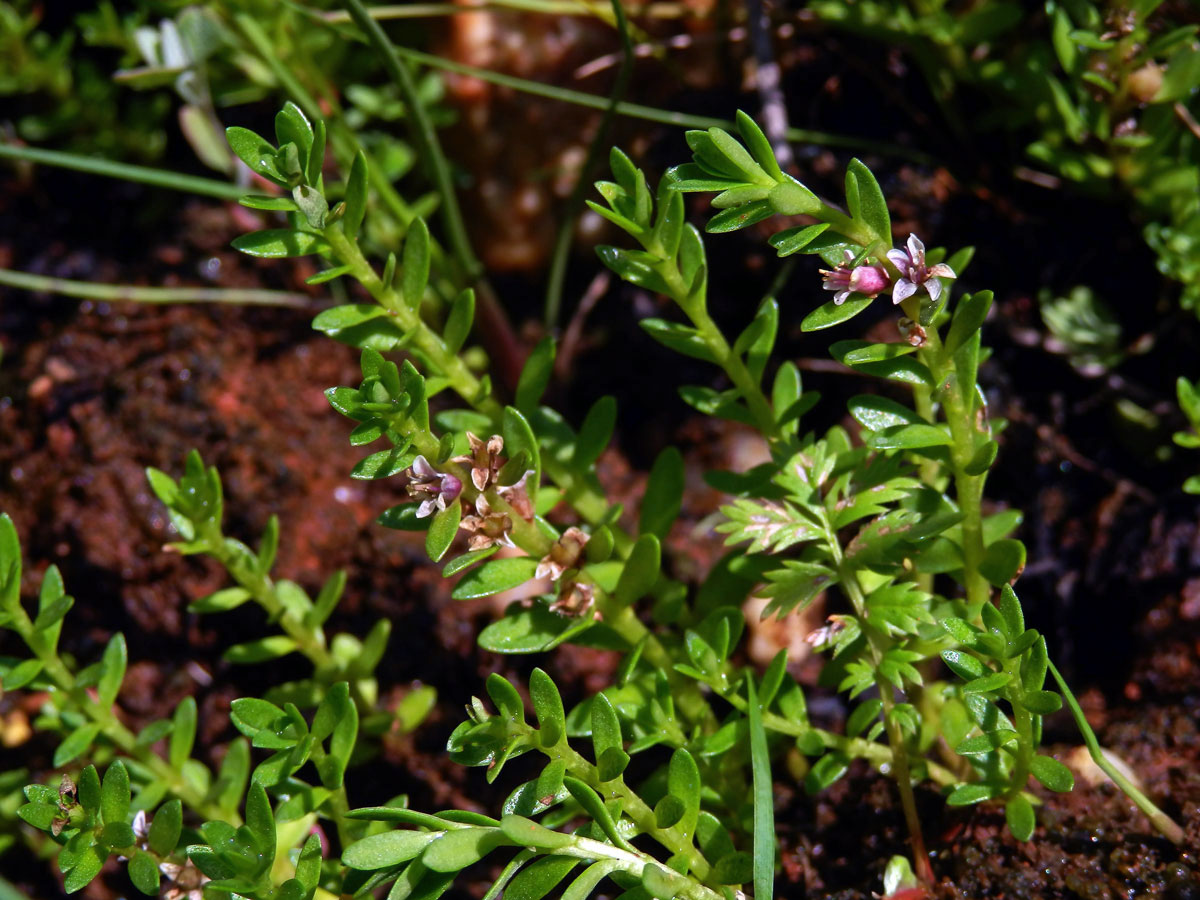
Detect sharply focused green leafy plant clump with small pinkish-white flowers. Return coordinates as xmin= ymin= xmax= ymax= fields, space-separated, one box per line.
xmin=0 ymin=106 xmax=1181 ymax=900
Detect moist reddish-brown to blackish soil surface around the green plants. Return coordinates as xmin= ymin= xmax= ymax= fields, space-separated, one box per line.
xmin=0 ymin=17 xmax=1200 ymax=900
